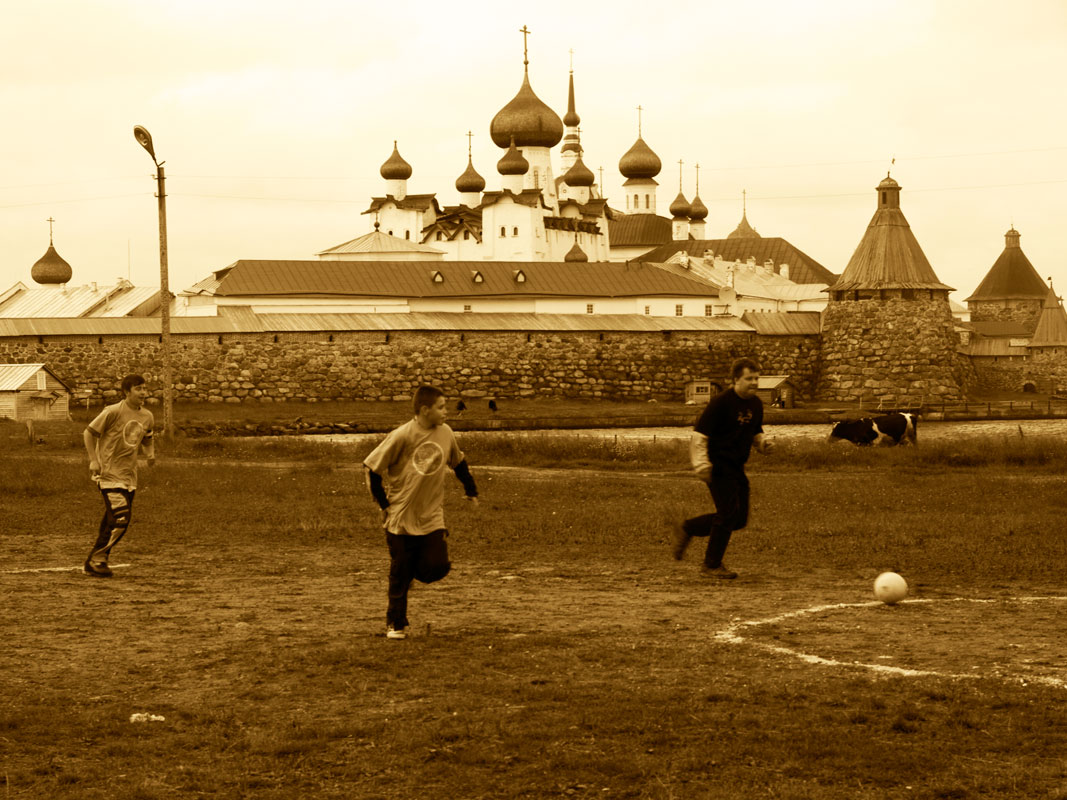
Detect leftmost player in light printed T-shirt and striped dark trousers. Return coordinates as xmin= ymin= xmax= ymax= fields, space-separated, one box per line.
xmin=82 ymin=375 xmax=156 ymax=578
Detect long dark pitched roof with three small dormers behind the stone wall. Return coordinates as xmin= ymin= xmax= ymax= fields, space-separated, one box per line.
xmin=201 ymin=260 xmax=718 ymax=298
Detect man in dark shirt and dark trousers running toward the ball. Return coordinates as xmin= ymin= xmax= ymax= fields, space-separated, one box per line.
xmin=672 ymin=358 xmax=774 ymax=578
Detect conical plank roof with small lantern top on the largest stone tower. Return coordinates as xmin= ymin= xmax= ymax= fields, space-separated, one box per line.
xmin=829 ymin=175 xmax=952 ymax=291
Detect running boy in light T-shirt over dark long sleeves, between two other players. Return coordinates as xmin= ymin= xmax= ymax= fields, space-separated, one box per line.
xmin=363 ymin=386 xmax=478 ymax=639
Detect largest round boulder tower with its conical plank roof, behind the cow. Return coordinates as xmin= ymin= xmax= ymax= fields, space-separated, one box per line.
xmin=818 ymin=175 xmax=968 ymax=406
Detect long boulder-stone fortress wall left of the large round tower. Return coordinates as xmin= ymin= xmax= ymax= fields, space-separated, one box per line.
xmin=0 ymin=331 xmax=819 ymax=403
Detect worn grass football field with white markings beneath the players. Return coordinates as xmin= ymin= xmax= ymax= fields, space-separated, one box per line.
xmin=0 ymin=436 xmax=1067 ymax=800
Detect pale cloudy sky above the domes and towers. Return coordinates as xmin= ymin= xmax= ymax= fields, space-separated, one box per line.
xmin=0 ymin=0 xmax=1067 ymax=301
